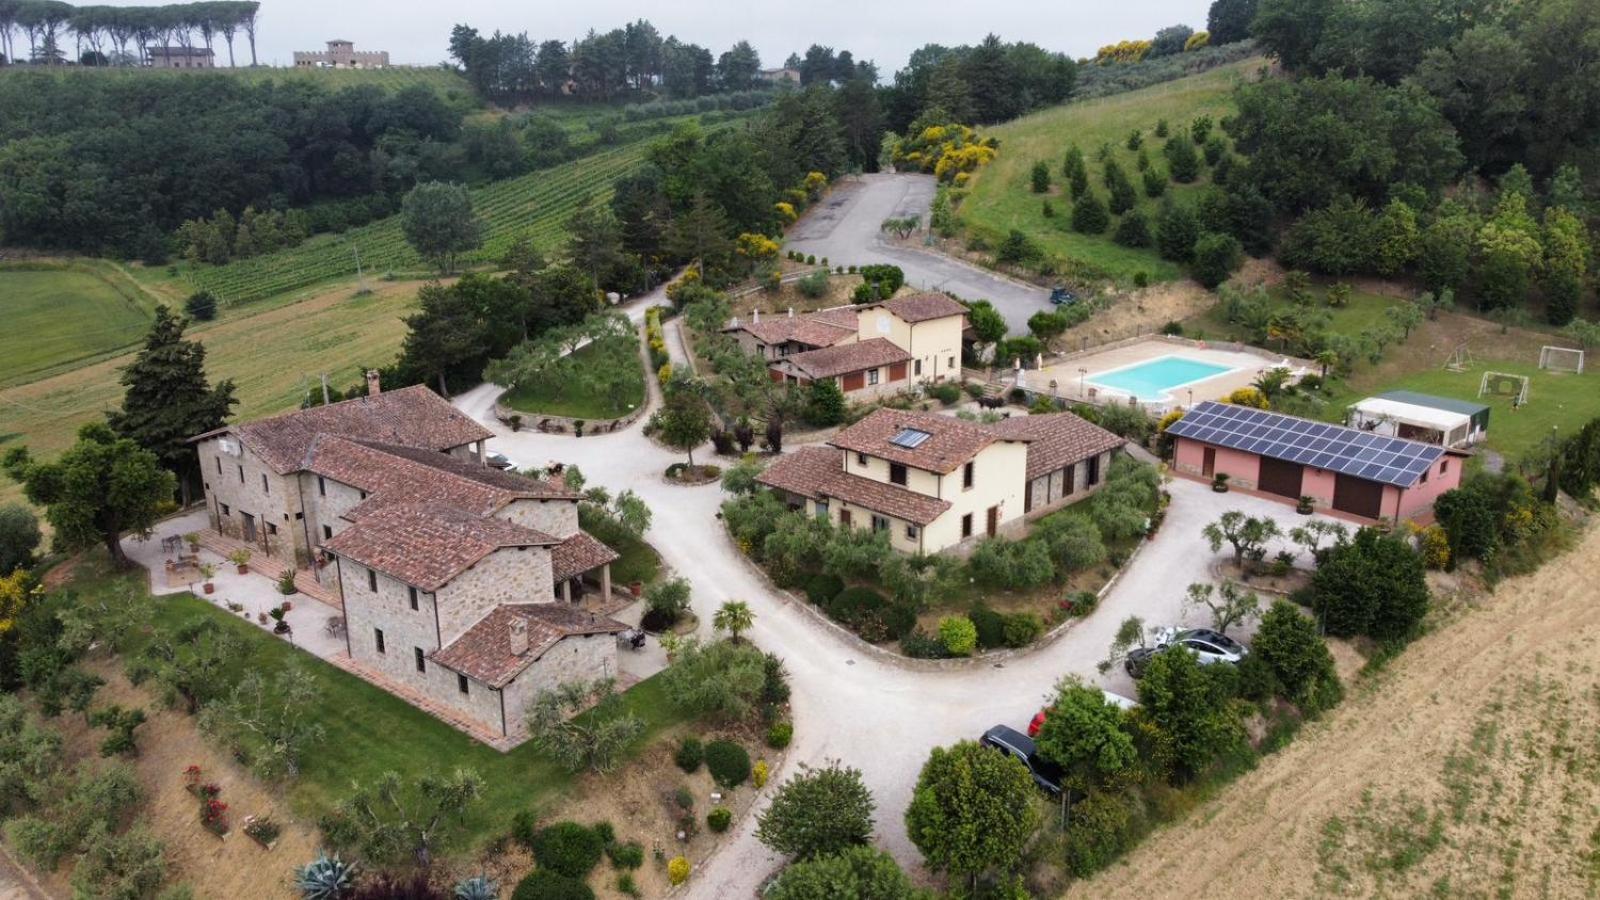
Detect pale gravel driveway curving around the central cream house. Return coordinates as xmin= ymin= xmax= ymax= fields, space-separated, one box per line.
xmin=456 ymin=361 xmax=1331 ymax=897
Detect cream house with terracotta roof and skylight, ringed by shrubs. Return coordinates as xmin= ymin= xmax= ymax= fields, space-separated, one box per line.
xmin=757 ymin=408 xmax=1125 ymax=552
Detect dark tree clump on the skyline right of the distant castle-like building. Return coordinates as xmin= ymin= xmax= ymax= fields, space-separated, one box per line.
xmin=450 ymin=19 xmax=762 ymax=102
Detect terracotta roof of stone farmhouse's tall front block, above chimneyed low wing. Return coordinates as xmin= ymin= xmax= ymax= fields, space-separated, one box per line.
xmin=323 ymin=503 xmax=562 ymax=591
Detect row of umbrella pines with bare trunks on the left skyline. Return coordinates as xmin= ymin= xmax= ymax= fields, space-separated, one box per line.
xmin=0 ymin=0 xmax=261 ymax=66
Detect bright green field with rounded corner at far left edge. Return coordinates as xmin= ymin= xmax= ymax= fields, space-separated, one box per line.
xmin=0 ymin=263 xmax=164 ymax=386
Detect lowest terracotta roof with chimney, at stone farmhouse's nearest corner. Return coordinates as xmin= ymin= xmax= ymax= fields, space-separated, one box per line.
xmin=432 ymin=604 xmax=627 ymax=689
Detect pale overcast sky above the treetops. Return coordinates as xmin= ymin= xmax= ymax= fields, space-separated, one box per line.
xmin=102 ymin=0 xmax=1210 ymax=70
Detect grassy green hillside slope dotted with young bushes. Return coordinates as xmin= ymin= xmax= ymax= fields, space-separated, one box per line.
xmin=960 ymin=59 xmax=1259 ymax=283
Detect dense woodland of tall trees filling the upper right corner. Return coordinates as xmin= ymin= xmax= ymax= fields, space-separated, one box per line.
xmin=1197 ymin=0 xmax=1600 ymax=325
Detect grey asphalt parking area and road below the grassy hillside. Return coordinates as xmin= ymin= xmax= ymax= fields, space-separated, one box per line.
xmin=784 ymin=175 xmax=1050 ymax=335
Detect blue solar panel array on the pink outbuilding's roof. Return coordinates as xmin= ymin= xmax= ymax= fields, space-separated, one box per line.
xmin=1166 ymin=400 xmax=1445 ymax=487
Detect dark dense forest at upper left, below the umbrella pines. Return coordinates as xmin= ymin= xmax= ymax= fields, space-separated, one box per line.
xmin=0 ymin=72 xmax=461 ymax=261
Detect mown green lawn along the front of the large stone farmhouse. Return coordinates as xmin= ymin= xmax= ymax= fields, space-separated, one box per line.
xmin=72 ymin=565 xmax=683 ymax=849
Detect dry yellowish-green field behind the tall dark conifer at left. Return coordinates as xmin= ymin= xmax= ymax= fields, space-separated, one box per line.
xmin=0 ymin=282 xmax=419 ymax=503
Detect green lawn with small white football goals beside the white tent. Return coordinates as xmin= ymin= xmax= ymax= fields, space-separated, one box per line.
xmin=1328 ymin=357 xmax=1600 ymax=460
